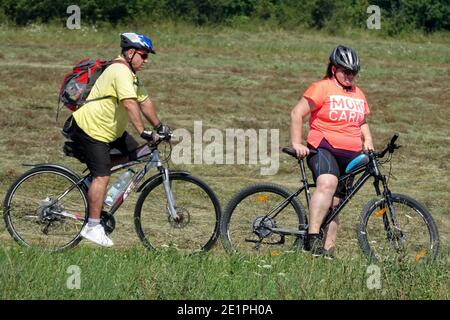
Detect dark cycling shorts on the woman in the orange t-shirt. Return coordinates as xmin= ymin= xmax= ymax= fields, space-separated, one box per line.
xmin=306 ymin=139 xmax=359 ymax=198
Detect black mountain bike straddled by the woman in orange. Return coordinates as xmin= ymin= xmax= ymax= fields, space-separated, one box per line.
xmin=220 ymin=134 xmax=439 ymax=262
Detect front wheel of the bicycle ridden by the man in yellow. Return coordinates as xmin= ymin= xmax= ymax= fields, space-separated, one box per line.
xmin=134 ymin=173 xmax=221 ymax=253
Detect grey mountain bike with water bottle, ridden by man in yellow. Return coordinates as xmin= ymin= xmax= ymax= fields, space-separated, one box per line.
xmin=3 ymin=135 xmax=221 ymax=252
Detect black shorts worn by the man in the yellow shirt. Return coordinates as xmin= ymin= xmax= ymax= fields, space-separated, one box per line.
xmin=70 ymin=119 xmax=139 ymax=177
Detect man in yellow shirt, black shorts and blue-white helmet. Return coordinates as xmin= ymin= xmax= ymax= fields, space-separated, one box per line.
xmin=71 ymin=32 xmax=170 ymax=247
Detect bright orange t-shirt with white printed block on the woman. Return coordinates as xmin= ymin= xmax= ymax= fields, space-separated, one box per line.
xmin=303 ymin=79 xmax=370 ymax=152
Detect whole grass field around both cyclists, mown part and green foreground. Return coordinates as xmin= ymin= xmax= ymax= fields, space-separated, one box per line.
xmin=0 ymin=25 xmax=450 ymax=299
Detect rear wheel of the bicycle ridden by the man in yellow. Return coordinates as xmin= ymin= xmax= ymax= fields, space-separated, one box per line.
xmin=3 ymin=167 xmax=88 ymax=250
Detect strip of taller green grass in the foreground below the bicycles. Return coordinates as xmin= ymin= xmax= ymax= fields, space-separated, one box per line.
xmin=0 ymin=247 xmax=449 ymax=300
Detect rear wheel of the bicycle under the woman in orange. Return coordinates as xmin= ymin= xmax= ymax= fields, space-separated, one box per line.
xmin=220 ymin=184 xmax=306 ymax=254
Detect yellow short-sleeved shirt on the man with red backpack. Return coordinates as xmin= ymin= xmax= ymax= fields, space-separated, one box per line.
xmin=73 ymin=57 xmax=148 ymax=143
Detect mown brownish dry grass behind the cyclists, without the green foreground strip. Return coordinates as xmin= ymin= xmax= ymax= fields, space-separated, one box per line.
xmin=0 ymin=26 xmax=450 ymax=258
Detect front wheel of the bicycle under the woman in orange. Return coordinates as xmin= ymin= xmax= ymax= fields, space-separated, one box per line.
xmin=358 ymin=194 xmax=439 ymax=262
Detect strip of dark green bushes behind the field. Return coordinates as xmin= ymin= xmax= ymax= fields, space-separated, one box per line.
xmin=0 ymin=0 xmax=450 ymax=35
